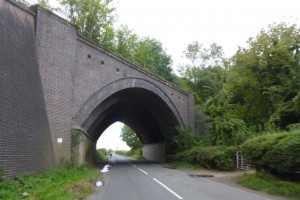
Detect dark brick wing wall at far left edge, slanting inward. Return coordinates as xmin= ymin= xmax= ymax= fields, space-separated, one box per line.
xmin=0 ymin=0 xmax=53 ymax=178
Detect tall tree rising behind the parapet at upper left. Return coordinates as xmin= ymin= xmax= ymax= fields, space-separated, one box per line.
xmin=61 ymin=0 xmax=115 ymax=49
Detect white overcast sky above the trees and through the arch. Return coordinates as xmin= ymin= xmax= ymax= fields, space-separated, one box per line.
xmin=46 ymin=0 xmax=300 ymax=149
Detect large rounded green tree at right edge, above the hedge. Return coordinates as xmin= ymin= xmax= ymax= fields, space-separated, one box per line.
xmin=225 ymin=23 xmax=300 ymax=128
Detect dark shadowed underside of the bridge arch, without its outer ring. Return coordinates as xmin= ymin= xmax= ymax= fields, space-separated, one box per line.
xmin=82 ymin=88 xmax=179 ymax=145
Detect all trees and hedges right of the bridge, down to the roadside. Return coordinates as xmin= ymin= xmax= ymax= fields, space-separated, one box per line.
xmin=173 ymin=23 xmax=300 ymax=177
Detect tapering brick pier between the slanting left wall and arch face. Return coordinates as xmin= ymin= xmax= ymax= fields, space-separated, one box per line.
xmin=36 ymin=7 xmax=76 ymax=165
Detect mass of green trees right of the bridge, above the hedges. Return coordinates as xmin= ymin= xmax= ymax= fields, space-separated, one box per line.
xmin=180 ymin=23 xmax=300 ymax=148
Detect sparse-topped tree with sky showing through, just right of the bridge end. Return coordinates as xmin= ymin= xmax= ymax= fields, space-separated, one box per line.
xmin=180 ymin=41 xmax=227 ymax=103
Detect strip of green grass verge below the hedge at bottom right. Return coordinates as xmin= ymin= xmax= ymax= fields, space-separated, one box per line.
xmin=238 ymin=172 xmax=300 ymax=199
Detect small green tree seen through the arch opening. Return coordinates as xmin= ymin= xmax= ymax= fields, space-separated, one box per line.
xmin=120 ymin=125 xmax=142 ymax=150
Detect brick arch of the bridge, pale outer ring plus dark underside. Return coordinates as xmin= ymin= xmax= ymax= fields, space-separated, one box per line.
xmin=73 ymin=78 xmax=184 ymax=144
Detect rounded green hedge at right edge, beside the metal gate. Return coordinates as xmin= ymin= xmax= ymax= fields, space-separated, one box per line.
xmin=241 ymin=128 xmax=300 ymax=180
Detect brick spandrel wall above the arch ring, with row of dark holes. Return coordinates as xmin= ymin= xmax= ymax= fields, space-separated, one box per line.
xmin=73 ymin=38 xmax=190 ymax=125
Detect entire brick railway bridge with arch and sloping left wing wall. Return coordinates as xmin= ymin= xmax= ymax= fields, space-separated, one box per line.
xmin=0 ymin=0 xmax=194 ymax=177
